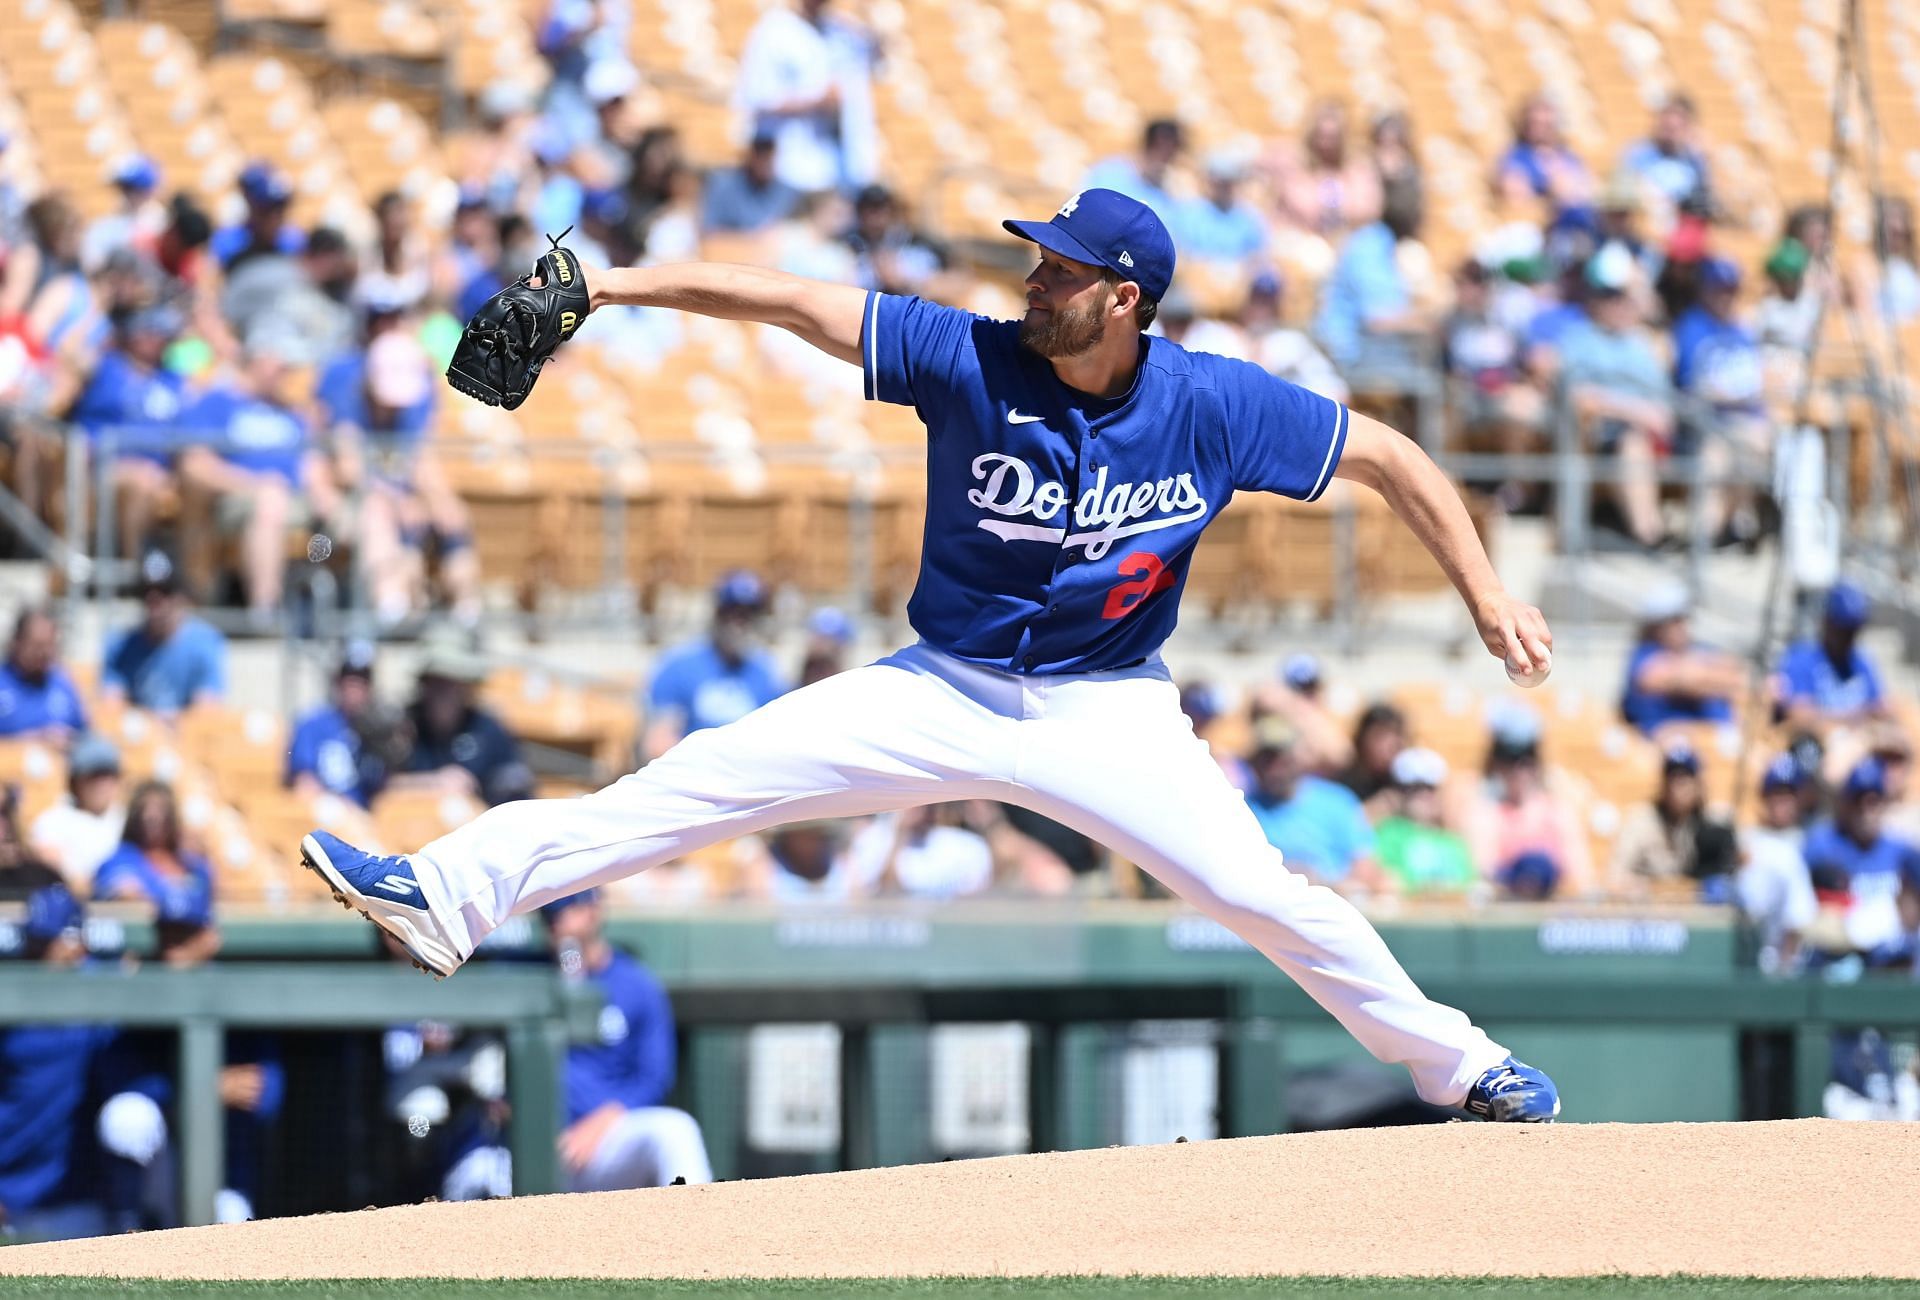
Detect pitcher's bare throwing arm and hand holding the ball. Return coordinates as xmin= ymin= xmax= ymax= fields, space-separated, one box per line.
xmin=1334 ymin=413 xmax=1553 ymax=680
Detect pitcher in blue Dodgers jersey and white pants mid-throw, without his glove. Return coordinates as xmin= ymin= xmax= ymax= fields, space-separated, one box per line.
xmin=301 ymin=190 xmax=1559 ymax=1121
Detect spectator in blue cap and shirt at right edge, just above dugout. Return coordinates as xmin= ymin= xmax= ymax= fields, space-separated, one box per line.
xmin=1805 ymin=758 xmax=1920 ymax=966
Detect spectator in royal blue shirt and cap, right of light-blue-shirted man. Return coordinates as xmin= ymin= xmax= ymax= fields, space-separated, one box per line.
xmin=1674 ymin=257 xmax=1772 ymax=543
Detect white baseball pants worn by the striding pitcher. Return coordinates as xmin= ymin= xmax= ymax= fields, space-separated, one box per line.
xmin=415 ymin=645 xmax=1507 ymax=1106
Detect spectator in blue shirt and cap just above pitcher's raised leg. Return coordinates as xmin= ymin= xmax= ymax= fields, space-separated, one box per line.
xmin=645 ymin=570 xmax=787 ymax=760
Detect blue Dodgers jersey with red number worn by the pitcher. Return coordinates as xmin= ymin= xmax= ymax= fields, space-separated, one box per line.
xmin=860 ymin=292 xmax=1348 ymax=674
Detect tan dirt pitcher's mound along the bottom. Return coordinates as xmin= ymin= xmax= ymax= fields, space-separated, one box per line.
xmin=0 ymin=1119 xmax=1920 ymax=1279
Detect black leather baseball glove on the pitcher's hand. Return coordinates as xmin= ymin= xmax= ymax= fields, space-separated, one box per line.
xmin=447 ymin=230 xmax=588 ymax=411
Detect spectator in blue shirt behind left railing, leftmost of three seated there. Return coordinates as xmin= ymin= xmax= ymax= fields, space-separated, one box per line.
xmin=69 ymin=305 xmax=188 ymax=557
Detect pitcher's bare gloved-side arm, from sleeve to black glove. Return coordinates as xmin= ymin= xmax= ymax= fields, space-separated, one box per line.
xmin=588 ymin=261 xmax=866 ymax=365
